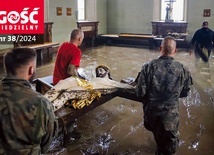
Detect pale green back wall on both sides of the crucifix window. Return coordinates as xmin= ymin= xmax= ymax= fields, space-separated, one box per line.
xmin=107 ymin=0 xmax=214 ymax=38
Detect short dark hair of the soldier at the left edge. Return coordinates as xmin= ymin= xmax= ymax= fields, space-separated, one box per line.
xmin=3 ymin=47 xmax=36 ymax=76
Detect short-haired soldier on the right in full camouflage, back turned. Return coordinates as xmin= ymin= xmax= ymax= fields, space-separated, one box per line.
xmin=136 ymin=36 xmax=192 ymax=155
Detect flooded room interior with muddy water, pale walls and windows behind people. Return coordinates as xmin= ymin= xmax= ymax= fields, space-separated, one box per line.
xmin=0 ymin=0 xmax=214 ymax=155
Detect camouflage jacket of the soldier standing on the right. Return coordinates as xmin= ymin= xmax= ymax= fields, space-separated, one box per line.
xmin=136 ymin=56 xmax=192 ymax=115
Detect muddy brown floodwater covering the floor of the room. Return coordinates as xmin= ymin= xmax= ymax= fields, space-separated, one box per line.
xmin=0 ymin=46 xmax=214 ymax=155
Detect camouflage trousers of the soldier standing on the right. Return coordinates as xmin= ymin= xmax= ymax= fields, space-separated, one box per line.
xmin=144 ymin=113 xmax=179 ymax=155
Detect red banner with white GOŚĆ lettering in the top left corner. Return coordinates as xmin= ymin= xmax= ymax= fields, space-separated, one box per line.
xmin=0 ymin=0 xmax=44 ymax=34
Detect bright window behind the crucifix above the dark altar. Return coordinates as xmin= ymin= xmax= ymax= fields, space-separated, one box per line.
xmin=160 ymin=0 xmax=185 ymax=21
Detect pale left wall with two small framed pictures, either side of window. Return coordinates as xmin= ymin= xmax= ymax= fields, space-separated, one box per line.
xmin=48 ymin=0 xmax=107 ymax=42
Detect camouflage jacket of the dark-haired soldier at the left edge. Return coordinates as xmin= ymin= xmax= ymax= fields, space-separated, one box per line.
xmin=0 ymin=77 xmax=56 ymax=155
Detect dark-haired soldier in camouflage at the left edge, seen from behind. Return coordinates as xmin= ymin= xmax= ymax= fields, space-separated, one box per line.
xmin=0 ymin=48 xmax=57 ymax=155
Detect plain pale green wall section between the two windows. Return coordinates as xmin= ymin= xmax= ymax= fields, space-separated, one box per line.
xmin=107 ymin=0 xmax=153 ymax=34
